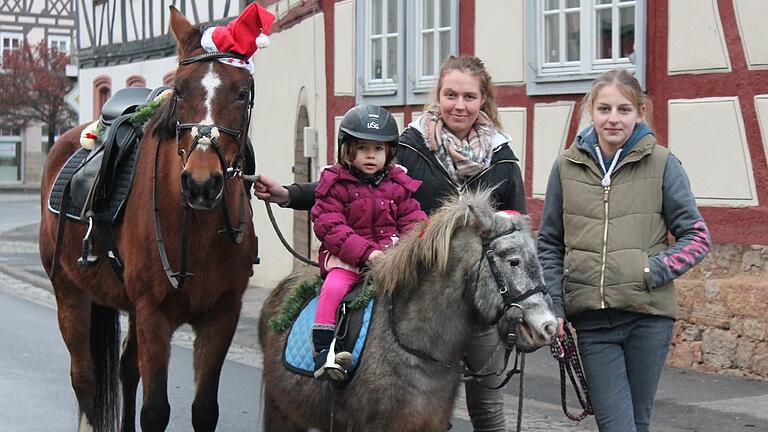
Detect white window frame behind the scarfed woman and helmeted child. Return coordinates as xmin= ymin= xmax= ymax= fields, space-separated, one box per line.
xmin=355 ymin=0 xmax=459 ymax=106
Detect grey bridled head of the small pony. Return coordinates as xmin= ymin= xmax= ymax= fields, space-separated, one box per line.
xmin=469 ymin=201 xmax=557 ymax=351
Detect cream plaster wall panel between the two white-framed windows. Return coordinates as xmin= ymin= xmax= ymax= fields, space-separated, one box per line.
xmin=475 ymin=0 xmax=525 ymax=84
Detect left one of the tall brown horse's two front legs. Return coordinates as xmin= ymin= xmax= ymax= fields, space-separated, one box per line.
xmin=136 ymin=302 xmax=173 ymax=432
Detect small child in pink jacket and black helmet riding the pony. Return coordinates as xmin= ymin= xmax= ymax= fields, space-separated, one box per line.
xmin=310 ymin=105 xmax=427 ymax=381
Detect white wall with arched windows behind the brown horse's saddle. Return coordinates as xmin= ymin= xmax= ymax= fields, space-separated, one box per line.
xmin=78 ymin=56 xmax=177 ymax=123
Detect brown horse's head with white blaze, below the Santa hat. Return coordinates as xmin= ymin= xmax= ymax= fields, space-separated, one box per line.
xmin=160 ymin=6 xmax=253 ymax=209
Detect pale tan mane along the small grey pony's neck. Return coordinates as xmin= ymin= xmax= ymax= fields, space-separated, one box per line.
xmin=372 ymin=189 xmax=494 ymax=294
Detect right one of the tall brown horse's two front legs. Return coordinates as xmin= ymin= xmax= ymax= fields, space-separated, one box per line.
xmin=191 ymin=292 xmax=242 ymax=432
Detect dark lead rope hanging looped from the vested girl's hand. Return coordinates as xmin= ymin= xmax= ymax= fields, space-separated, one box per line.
xmin=550 ymin=326 xmax=594 ymax=421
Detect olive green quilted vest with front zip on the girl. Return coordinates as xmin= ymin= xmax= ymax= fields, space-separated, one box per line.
xmin=559 ymin=135 xmax=677 ymax=318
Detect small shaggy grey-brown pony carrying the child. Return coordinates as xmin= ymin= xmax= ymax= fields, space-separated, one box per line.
xmin=259 ymin=191 xmax=557 ymax=432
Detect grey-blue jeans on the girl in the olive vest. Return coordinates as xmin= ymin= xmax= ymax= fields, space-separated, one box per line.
xmin=576 ymin=315 xmax=674 ymax=432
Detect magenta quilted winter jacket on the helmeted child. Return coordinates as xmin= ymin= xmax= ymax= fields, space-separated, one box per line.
xmin=310 ymin=164 xmax=427 ymax=273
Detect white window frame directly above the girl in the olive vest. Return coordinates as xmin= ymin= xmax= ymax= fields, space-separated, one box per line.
xmin=526 ymin=0 xmax=647 ymax=96
